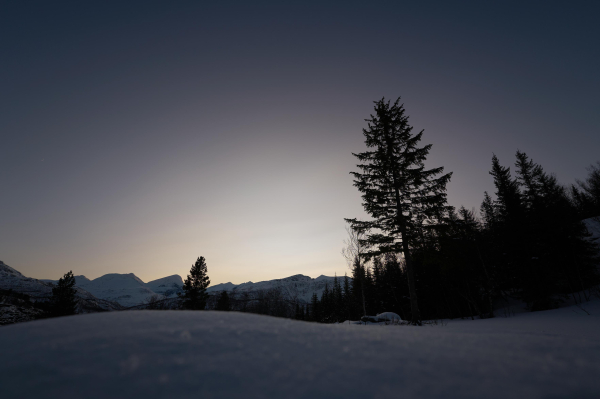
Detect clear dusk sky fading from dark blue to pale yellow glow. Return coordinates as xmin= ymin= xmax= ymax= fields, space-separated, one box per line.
xmin=0 ymin=1 xmax=600 ymax=284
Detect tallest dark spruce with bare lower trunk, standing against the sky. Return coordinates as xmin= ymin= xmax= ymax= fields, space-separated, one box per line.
xmin=346 ymin=99 xmax=451 ymax=325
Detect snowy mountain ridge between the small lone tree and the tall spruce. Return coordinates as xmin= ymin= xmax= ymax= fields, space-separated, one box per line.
xmin=206 ymin=274 xmax=344 ymax=303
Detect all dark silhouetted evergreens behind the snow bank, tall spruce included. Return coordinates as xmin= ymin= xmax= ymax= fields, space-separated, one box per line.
xmin=43 ymin=99 xmax=600 ymax=325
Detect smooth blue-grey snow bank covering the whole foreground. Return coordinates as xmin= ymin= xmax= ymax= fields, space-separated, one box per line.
xmin=0 ymin=302 xmax=600 ymax=399
